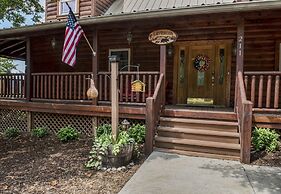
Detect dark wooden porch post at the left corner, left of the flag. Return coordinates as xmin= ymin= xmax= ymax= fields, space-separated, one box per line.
xmin=25 ymin=37 xmax=31 ymax=101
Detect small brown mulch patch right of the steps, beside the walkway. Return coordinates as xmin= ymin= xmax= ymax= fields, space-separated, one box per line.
xmin=251 ymin=146 xmax=281 ymax=167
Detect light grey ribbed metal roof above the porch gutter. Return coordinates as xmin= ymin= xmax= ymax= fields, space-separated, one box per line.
xmin=105 ymin=0 xmax=254 ymax=15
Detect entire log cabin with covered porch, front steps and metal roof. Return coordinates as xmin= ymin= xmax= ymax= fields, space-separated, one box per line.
xmin=0 ymin=0 xmax=281 ymax=163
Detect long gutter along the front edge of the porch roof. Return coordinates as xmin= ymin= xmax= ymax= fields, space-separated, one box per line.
xmin=0 ymin=0 xmax=281 ymax=38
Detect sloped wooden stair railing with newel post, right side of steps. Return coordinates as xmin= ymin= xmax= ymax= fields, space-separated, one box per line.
xmin=236 ymin=72 xmax=253 ymax=164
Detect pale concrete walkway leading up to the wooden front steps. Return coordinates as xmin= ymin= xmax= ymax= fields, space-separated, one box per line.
xmin=119 ymin=152 xmax=281 ymax=194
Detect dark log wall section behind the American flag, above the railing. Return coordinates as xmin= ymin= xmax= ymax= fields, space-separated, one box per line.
xmin=31 ymin=32 xmax=92 ymax=73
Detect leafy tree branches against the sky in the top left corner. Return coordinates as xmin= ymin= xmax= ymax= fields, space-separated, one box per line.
xmin=0 ymin=0 xmax=44 ymax=27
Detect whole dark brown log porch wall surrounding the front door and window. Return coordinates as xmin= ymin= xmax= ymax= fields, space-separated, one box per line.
xmin=32 ymin=10 xmax=281 ymax=106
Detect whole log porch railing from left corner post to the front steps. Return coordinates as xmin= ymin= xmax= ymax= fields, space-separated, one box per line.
xmin=31 ymin=72 xmax=159 ymax=104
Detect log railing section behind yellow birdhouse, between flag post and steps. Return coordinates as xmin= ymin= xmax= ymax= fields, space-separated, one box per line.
xmin=98 ymin=71 xmax=159 ymax=103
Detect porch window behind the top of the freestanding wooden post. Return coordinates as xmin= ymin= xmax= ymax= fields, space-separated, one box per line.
xmin=109 ymin=48 xmax=131 ymax=71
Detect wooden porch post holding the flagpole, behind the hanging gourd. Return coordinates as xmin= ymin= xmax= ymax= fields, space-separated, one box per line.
xmin=92 ymin=29 xmax=98 ymax=105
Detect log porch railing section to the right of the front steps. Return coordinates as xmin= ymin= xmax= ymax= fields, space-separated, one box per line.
xmin=244 ymin=71 xmax=281 ymax=111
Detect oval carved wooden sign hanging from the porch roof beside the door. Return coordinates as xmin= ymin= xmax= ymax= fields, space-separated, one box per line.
xmin=148 ymin=29 xmax=178 ymax=45
